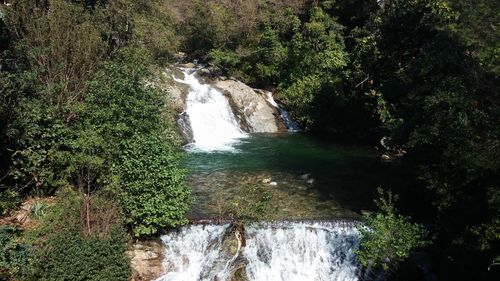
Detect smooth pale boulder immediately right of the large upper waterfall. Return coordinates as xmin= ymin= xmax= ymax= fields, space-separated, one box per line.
xmin=213 ymin=77 xmax=281 ymax=133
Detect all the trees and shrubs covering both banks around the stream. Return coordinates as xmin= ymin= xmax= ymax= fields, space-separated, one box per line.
xmin=0 ymin=0 xmax=500 ymax=280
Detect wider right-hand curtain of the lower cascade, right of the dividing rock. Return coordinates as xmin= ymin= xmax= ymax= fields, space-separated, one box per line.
xmin=244 ymin=222 xmax=358 ymax=281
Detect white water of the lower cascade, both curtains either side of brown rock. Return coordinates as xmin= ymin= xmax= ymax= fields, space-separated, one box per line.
xmin=157 ymin=222 xmax=358 ymax=281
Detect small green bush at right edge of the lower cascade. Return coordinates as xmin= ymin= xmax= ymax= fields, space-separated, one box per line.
xmin=357 ymin=188 xmax=428 ymax=270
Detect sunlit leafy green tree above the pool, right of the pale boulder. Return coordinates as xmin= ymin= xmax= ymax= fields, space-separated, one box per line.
xmin=278 ymin=7 xmax=348 ymax=128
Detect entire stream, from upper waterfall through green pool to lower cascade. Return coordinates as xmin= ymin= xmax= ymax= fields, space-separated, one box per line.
xmin=157 ymin=69 xmax=402 ymax=281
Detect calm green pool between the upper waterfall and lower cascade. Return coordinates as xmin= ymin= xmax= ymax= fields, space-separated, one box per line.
xmin=187 ymin=133 xmax=401 ymax=219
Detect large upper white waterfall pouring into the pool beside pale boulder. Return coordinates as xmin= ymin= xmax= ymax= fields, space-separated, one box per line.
xmin=174 ymin=69 xmax=247 ymax=151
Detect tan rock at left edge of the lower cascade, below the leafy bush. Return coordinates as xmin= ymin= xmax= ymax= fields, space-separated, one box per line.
xmin=127 ymin=238 xmax=164 ymax=281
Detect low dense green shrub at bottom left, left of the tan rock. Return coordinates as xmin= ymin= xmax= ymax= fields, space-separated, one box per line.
xmin=23 ymin=190 xmax=131 ymax=280
